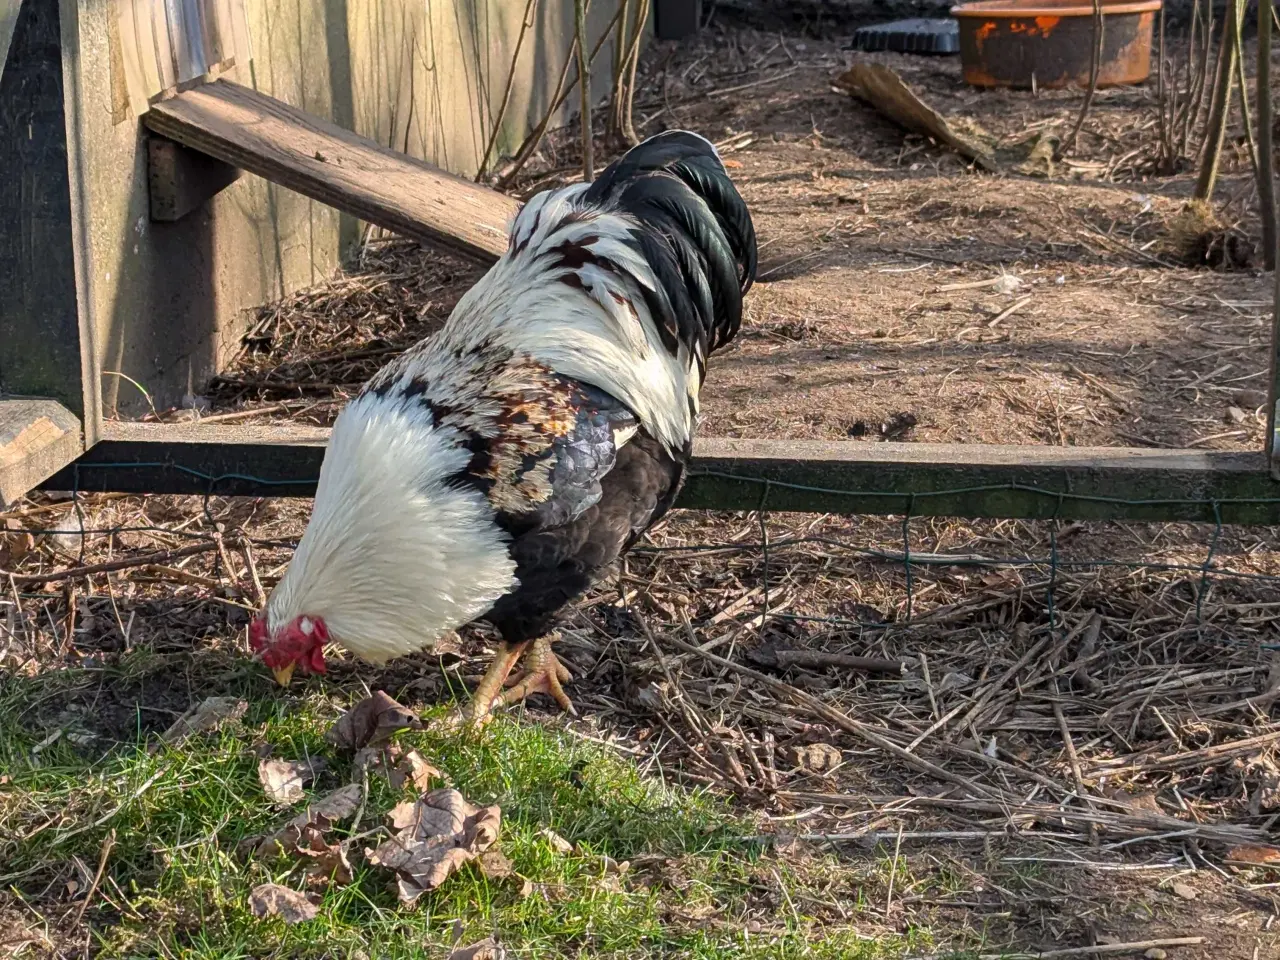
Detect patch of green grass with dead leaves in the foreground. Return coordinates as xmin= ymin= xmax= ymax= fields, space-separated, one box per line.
xmin=0 ymin=664 xmax=928 ymax=960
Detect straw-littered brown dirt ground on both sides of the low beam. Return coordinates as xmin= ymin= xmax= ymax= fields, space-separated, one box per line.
xmin=0 ymin=9 xmax=1280 ymax=960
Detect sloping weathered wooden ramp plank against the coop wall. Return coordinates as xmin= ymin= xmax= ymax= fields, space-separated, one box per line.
xmin=143 ymin=79 xmax=518 ymax=262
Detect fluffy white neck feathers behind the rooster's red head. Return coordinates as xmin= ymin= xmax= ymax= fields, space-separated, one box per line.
xmin=266 ymin=394 xmax=516 ymax=663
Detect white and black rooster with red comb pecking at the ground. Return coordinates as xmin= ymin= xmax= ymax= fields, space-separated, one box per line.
xmin=250 ymin=131 xmax=756 ymax=721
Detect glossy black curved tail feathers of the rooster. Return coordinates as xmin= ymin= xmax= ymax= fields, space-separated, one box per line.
xmin=585 ymin=131 xmax=756 ymax=361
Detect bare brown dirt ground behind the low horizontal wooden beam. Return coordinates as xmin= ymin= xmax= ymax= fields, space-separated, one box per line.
xmin=216 ymin=15 xmax=1271 ymax=449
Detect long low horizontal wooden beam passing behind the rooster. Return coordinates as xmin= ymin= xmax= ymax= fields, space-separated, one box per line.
xmin=37 ymin=424 xmax=1280 ymax=524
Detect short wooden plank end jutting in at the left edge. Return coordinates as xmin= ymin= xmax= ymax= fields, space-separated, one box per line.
xmin=0 ymin=399 xmax=83 ymax=507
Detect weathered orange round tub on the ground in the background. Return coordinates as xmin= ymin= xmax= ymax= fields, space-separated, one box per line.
xmin=951 ymin=0 xmax=1161 ymax=90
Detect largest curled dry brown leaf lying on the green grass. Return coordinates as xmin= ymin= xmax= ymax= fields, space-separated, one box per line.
xmin=365 ymin=788 xmax=502 ymax=904
